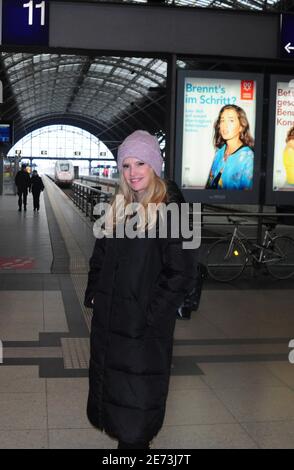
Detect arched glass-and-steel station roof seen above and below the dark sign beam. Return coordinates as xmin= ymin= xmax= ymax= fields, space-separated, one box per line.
xmin=0 ymin=0 xmax=286 ymax=148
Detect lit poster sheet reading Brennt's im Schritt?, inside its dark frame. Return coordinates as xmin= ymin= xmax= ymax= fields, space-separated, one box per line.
xmin=181 ymin=72 xmax=257 ymax=191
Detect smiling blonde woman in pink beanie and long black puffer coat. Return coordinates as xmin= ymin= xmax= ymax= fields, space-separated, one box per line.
xmin=85 ymin=131 xmax=196 ymax=449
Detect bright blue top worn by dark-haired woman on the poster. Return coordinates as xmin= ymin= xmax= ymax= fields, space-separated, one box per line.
xmin=206 ymin=144 xmax=254 ymax=190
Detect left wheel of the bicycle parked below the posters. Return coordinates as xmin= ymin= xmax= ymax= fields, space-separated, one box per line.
xmin=206 ymin=238 xmax=247 ymax=282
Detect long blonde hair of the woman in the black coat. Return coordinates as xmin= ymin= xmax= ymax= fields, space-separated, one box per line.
xmin=105 ymin=171 xmax=167 ymax=234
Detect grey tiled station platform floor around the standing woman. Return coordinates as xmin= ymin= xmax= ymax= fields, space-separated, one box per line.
xmin=0 ymin=177 xmax=294 ymax=449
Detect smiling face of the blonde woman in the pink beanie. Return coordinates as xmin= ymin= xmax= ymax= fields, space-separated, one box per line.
xmin=122 ymin=157 xmax=153 ymax=194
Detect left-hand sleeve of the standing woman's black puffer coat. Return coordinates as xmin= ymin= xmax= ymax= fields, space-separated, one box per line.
xmin=84 ymin=238 xmax=105 ymax=308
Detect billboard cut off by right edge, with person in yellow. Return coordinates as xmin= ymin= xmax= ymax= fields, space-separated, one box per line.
xmin=266 ymin=75 xmax=294 ymax=204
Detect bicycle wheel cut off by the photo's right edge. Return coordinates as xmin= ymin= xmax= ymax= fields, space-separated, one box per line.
xmin=264 ymin=236 xmax=294 ymax=279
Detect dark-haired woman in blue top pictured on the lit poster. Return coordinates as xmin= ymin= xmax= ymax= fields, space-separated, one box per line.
xmin=206 ymin=104 xmax=254 ymax=190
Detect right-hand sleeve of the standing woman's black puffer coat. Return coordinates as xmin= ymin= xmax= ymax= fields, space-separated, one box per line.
xmin=147 ymin=235 xmax=197 ymax=325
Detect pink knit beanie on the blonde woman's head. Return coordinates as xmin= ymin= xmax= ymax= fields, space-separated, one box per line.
xmin=117 ymin=131 xmax=163 ymax=177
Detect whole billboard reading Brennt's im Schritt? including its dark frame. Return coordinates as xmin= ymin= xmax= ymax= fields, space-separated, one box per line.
xmin=175 ymin=70 xmax=263 ymax=204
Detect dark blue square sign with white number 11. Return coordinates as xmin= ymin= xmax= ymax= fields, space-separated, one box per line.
xmin=2 ymin=0 xmax=49 ymax=46
